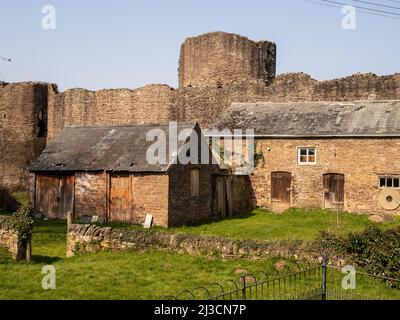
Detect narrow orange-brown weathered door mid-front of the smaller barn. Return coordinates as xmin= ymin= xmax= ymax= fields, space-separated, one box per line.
xmin=110 ymin=174 xmax=134 ymax=222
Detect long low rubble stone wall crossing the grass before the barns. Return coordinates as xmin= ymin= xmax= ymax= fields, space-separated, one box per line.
xmin=67 ymin=224 xmax=345 ymax=265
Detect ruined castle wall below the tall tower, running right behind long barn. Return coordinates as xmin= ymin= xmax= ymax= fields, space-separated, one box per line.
xmin=171 ymin=73 xmax=400 ymax=128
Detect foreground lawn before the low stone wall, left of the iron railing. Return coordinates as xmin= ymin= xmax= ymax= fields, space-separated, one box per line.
xmin=0 ymin=221 xmax=288 ymax=299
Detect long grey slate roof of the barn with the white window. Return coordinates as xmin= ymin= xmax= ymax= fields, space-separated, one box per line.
xmin=215 ymin=100 xmax=400 ymax=137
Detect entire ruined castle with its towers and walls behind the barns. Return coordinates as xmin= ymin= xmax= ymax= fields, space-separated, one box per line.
xmin=0 ymin=32 xmax=400 ymax=190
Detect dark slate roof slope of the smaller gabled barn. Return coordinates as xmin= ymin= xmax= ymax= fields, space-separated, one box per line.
xmin=28 ymin=123 xmax=199 ymax=172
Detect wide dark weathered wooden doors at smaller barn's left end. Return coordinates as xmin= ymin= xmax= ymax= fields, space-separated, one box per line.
xmin=35 ymin=175 xmax=75 ymax=219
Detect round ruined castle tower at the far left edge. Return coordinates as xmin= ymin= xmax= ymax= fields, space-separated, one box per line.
xmin=0 ymin=82 xmax=53 ymax=189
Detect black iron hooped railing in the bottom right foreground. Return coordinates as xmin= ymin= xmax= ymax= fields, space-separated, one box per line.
xmin=164 ymin=259 xmax=400 ymax=300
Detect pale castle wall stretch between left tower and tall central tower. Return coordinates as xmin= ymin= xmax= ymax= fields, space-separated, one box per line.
xmin=48 ymin=84 xmax=176 ymax=140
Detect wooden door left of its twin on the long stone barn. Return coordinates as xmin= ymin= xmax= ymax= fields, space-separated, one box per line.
xmin=271 ymin=172 xmax=292 ymax=211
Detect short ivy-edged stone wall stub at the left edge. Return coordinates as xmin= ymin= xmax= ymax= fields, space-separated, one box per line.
xmin=0 ymin=216 xmax=26 ymax=260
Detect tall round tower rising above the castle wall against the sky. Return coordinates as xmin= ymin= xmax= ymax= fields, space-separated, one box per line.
xmin=179 ymin=32 xmax=276 ymax=88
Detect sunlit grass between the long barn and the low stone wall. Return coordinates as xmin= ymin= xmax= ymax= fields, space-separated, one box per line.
xmin=108 ymin=209 xmax=400 ymax=240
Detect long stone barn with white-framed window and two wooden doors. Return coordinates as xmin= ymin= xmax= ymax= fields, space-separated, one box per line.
xmin=217 ymin=101 xmax=400 ymax=216
